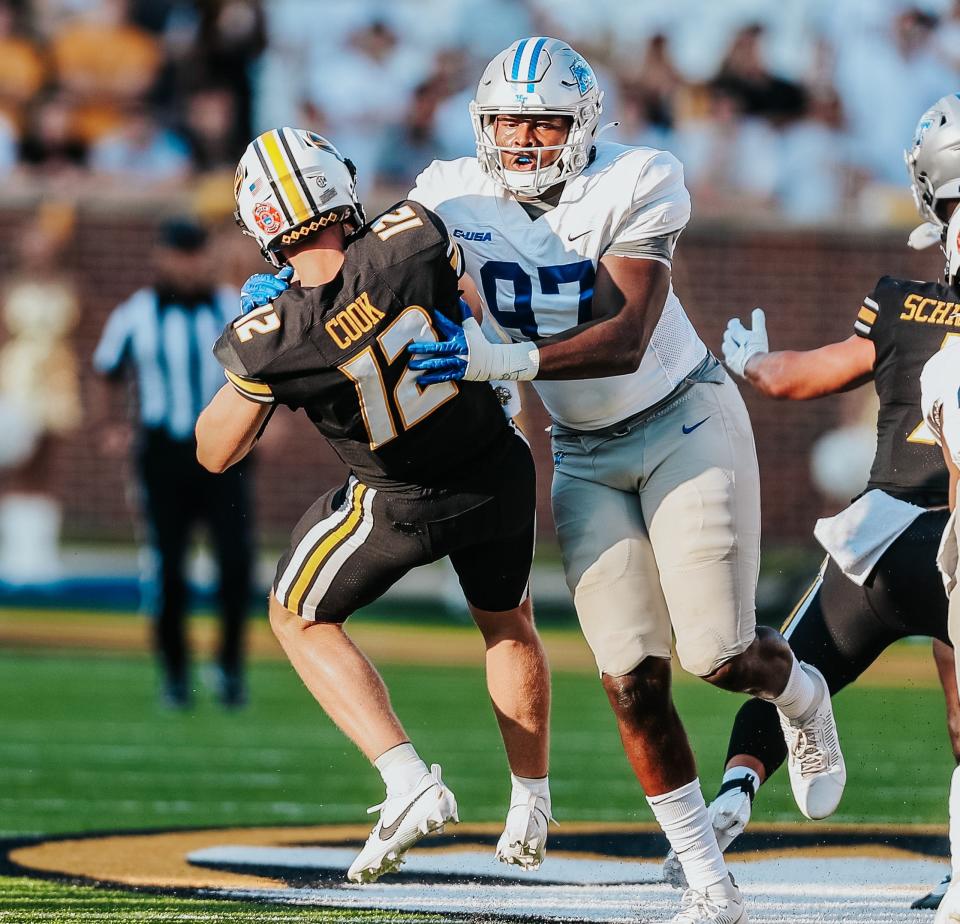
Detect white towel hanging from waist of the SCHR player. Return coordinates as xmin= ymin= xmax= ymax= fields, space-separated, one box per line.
xmin=813 ymin=489 xmax=924 ymax=586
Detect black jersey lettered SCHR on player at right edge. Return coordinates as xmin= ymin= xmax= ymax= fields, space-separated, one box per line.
xmin=854 ymin=276 xmax=960 ymax=507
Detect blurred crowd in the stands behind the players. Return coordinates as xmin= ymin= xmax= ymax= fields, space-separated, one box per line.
xmin=0 ymin=0 xmax=960 ymax=225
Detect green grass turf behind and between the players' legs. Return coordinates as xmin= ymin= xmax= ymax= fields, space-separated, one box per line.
xmin=0 ymin=617 xmax=952 ymax=924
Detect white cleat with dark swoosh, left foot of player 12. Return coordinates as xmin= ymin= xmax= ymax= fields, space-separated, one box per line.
xmin=347 ymin=764 xmax=460 ymax=882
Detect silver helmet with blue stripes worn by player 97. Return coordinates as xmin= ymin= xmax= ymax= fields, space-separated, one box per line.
xmin=470 ymin=37 xmax=603 ymax=197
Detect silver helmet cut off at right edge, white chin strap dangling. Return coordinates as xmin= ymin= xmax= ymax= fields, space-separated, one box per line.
xmin=904 ymin=93 xmax=960 ymax=235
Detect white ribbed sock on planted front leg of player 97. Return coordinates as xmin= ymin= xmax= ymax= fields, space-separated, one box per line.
xmin=647 ymin=779 xmax=729 ymax=892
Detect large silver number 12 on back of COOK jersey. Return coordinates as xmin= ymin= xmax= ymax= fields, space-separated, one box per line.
xmin=337 ymin=305 xmax=459 ymax=449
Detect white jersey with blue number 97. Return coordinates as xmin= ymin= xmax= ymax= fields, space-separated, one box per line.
xmin=410 ymin=142 xmax=707 ymax=430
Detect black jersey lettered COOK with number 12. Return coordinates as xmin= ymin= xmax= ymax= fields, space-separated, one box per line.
xmin=214 ymin=201 xmax=508 ymax=490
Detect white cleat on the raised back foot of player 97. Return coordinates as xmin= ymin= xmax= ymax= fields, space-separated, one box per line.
xmin=777 ymin=664 xmax=847 ymax=820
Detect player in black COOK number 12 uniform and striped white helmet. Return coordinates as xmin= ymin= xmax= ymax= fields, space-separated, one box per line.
xmin=197 ymin=128 xmax=551 ymax=882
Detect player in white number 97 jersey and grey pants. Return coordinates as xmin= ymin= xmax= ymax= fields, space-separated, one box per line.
xmin=409 ymin=37 xmax=845 ymax=924
